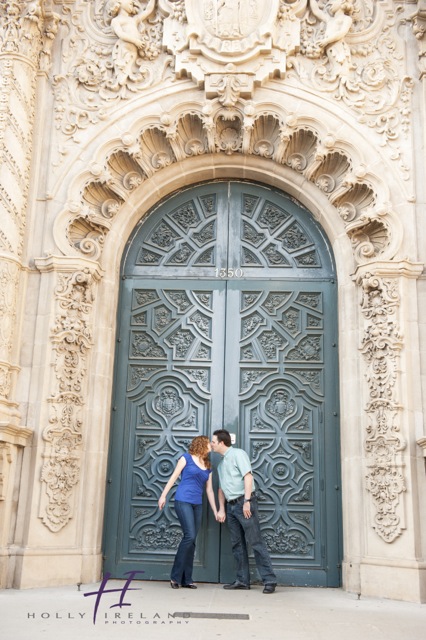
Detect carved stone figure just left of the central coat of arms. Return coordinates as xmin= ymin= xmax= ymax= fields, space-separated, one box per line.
xmin=108 ymin=0 xmax=155 ymax=89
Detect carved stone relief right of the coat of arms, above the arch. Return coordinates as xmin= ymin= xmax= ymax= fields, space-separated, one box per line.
xmin=288 ymin=0 xmax=413 ymax=179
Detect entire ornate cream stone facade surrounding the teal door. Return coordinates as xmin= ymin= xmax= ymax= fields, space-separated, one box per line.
xmin=0 ymin=0 xmax=426 ymax=601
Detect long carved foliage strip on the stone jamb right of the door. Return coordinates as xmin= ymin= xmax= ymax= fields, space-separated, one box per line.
xmin=358 ymin=273 xmax=406 ymax=542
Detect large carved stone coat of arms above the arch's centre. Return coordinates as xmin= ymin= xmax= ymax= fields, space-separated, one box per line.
xmin=162 ymin=0 xmax=300 ymax=97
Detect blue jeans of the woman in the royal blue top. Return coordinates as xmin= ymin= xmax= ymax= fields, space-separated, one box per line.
xmin=170 ymin=500 xmax=203 ymax=585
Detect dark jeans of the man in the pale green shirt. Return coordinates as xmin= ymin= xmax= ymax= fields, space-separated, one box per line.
xmin=226 ymin=498 xmax=277 ymax=585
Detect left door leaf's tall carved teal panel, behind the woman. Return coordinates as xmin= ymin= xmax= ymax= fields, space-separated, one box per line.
xmin=106 ymin=278 xmax=226 ymax=580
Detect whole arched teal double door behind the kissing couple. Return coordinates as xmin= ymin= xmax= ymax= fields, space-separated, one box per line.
xmin=104 ymin=182 xmax=341 ymax=586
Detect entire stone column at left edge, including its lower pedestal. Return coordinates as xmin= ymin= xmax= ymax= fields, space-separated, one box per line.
xmin=0 ymin=0 xmax=57 ymax=587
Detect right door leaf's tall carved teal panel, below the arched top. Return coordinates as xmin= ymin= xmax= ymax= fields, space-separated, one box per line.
xmin=224 ymin=281 xmax=338 ymax=585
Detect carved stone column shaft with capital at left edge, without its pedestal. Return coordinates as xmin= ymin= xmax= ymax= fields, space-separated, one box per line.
xmin=0 ymin=0 xmax=57 ymax=430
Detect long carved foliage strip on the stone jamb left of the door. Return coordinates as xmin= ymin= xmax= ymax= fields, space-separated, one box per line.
xmin=40 ymin=268 xmax=97 ymax=532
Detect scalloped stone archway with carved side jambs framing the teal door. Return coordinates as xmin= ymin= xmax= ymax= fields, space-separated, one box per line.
xmin=19 ymin=92 xmax=419 ymax=604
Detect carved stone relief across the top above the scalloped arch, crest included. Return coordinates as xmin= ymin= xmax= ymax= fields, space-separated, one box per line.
xmin=48 ymin=0 xmax=414 ymax=185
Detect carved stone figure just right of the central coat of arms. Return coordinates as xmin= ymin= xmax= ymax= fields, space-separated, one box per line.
xmin=309 ymin=0 xmax=354 ymax=77
